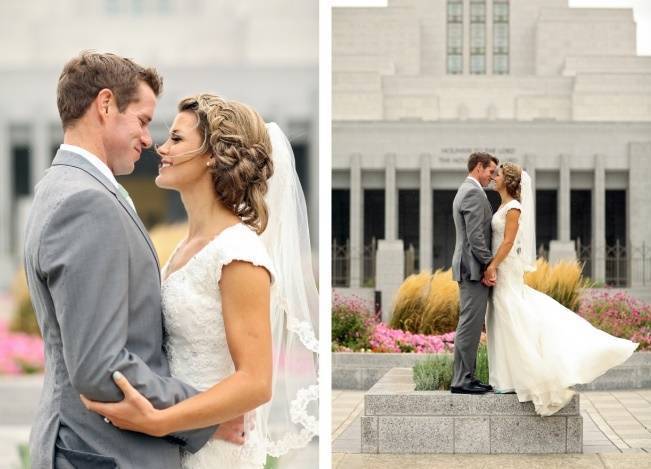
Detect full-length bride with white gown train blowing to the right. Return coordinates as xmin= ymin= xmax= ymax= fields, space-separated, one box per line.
xmin=486 ymin=163 xmax=638 ymax=416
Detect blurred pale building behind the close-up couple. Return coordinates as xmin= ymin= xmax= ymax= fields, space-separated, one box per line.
xmin=0 ymin=0 xmax=318 ymax=291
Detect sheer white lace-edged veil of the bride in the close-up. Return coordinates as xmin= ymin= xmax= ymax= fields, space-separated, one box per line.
xmin=260 ymin=123 xmax=319 ymax=456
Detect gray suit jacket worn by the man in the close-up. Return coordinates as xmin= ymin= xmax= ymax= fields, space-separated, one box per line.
xmin=25 ymin=150 xmax=215 ymax=469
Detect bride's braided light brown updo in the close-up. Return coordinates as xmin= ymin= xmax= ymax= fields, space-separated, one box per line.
xmin=178 ymin=94 xmax=273 ymax=234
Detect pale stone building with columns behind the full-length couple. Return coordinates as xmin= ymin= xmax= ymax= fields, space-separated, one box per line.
xmin=332 ymin=0 xmax=651 ymax=306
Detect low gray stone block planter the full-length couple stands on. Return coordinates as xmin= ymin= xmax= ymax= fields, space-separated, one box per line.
xmin=361 ymin=368 xmax=583 ymax=454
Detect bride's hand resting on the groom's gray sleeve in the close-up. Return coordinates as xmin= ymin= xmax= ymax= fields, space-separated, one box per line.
xmin=81 ymin=371 xmax=167 ymax=436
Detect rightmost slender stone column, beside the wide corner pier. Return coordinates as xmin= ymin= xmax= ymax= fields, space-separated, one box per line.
xmin=592 ymin=155 xmax=606 ymax=282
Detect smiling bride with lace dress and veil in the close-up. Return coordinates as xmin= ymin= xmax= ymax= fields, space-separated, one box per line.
xmin=85 ymin=94 xmax=318 ymax=469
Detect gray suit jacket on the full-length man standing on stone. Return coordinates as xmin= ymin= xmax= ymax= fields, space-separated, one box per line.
xmin=452 ymin=179 xmax=493 ymax=282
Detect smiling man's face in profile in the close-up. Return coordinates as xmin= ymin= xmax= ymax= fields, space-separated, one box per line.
xmin=104 ymin=82 xmax=156 ymax=176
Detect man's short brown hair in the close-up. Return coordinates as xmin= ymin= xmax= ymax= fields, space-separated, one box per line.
xmin=57 ymin=51 xmax=163 ymax=129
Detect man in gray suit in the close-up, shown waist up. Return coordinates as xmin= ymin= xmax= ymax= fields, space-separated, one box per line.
xmin=25 ymin=52 xmax=241 ymax=469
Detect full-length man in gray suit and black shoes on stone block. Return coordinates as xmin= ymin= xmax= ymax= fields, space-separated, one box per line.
xmin=450 ymin=152 xmax=499 ymax=394
